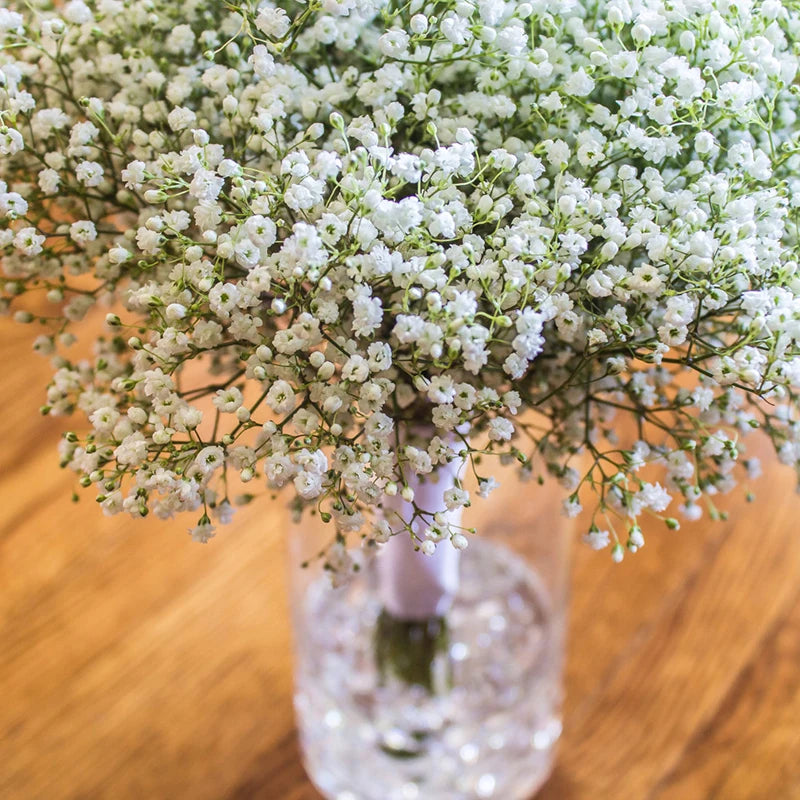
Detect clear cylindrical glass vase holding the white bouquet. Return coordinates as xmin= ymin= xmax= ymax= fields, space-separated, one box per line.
xmin=290 ymin=462 xmax=571 ymax=800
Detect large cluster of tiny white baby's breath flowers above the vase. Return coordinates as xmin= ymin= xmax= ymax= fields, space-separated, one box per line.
xmin=0 ymin=0 xmax=800 ymax=569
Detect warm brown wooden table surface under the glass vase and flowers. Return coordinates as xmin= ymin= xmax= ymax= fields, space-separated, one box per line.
xmin=0 ymin=320 xmax=800 ymax=800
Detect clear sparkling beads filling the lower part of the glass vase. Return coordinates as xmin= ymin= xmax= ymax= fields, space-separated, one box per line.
xmin=295 ymin=541 xmax=563 ymax=800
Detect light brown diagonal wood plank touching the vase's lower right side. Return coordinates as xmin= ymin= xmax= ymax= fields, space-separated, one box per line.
xmin=543 ymin=460 xmax=800 ymax=798
